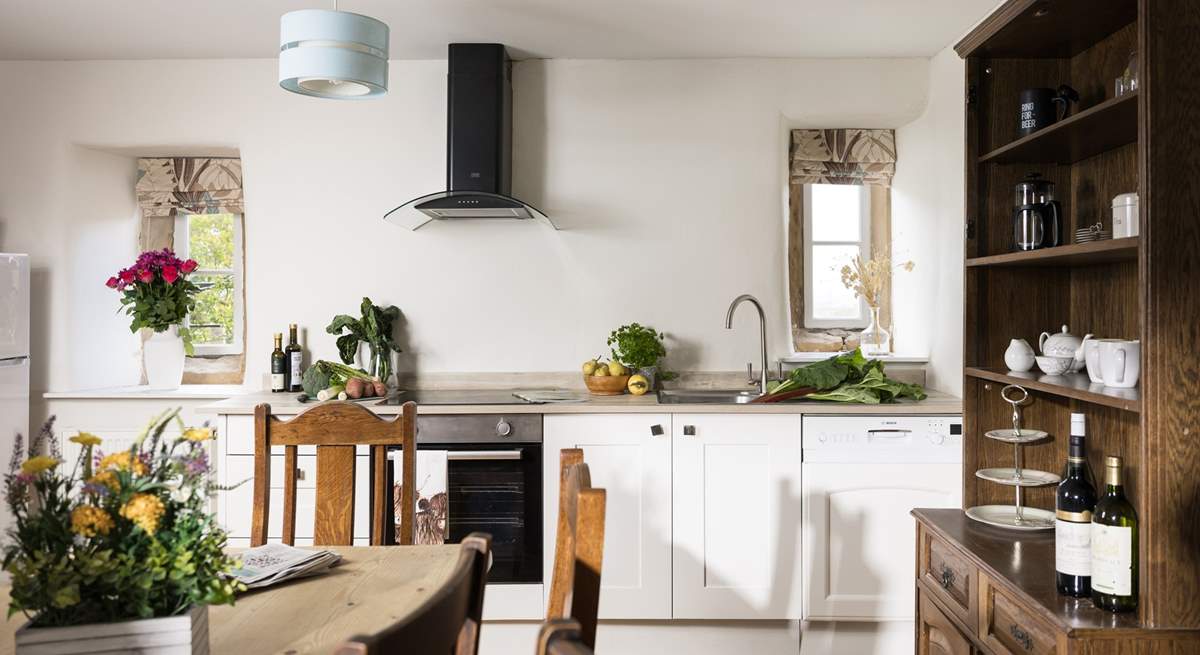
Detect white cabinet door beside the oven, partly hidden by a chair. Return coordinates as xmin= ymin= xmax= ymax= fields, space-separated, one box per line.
xmin=542 ymin=414 xmax=671 ymax=619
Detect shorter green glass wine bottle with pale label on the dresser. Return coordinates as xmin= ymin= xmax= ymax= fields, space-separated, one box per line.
xmin=1092 ymin=456 xmax=1138 ymax=612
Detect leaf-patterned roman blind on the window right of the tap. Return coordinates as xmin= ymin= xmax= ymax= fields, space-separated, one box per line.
xmin=792 ymin=130 xmax=896 ymax=187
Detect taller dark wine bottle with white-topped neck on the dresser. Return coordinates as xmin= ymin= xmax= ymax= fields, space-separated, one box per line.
xmin=1054 ymin=414 xmax=1096 ymax=597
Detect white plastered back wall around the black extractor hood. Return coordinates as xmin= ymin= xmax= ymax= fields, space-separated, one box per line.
xmin=0 ymin=53 xmax=961 ymax=390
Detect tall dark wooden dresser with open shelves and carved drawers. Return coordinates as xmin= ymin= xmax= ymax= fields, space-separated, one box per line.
xmin=913 ymin=0 xmax=1200 ymax=655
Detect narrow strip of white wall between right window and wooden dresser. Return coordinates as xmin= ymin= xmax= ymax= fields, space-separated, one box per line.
xmin=892 ymin=48 xmax=966 ymax=396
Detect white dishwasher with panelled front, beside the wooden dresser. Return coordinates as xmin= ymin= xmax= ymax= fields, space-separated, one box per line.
xmin=800 ymin=415 xmax=962 ymax=621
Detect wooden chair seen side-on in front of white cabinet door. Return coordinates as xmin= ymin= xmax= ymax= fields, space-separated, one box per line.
xmin=546 ymin=449 xmax=606 ymax=649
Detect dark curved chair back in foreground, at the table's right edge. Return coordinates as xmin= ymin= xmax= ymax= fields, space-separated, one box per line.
xmin=336 ymin=533 xmax=492 ymax=655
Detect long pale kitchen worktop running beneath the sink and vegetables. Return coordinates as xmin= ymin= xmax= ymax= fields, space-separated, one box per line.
xmin=197 ymin=391 xmax=962 ymax=415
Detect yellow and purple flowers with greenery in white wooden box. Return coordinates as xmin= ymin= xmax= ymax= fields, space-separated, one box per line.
xmin=2 ymin=409 xmax=242 ymax=627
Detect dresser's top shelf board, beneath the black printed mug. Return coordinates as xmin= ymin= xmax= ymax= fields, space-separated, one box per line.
xmin=979 ymin=92 xmax=1138 ymax=164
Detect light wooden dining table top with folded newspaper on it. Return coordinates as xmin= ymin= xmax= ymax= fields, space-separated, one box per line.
xmin=0 ymin=545 xmax=460 ymax=655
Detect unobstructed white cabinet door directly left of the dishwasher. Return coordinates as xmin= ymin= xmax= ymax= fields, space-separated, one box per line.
xmin=672 ymin=414 xmax=802 ymax=619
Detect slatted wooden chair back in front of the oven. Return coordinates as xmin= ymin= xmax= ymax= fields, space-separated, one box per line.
xmin=250 ymin=401 xmax=416 ymax=546
